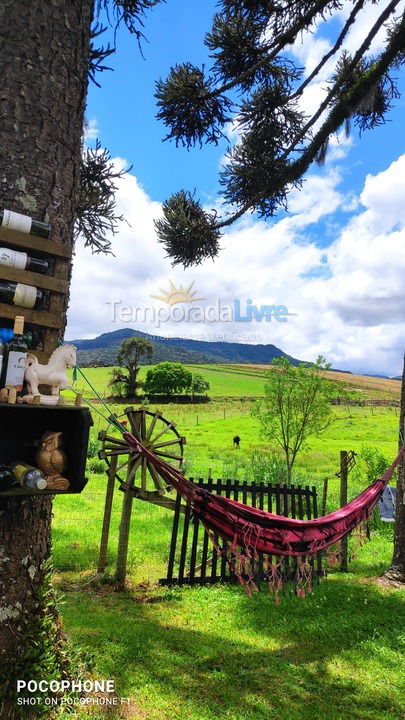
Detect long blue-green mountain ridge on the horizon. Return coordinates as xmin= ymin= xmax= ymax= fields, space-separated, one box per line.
xmin=68 ymin=328 xmax=302 ymax=367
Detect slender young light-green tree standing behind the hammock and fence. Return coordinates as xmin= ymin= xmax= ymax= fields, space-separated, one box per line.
xmin=252 ymin=357 xmax=344 ymax=485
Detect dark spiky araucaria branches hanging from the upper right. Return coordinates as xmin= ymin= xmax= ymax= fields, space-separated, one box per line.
xmin=156 ymin=0 xmax=405 ymax=267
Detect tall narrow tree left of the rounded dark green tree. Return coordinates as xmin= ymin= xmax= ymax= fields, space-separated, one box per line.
xmin=109 ymin=337 xmax=153 ymax=398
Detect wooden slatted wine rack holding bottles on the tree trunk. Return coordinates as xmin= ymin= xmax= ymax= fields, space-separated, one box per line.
xmin=0 ymin=227 xmax=72 ymax=363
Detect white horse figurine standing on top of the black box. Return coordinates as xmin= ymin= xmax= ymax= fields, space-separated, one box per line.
xmin=24 ymin=345 xmax=76 ymax=395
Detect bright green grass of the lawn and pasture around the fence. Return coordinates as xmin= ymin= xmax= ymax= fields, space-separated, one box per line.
xmin=49 ymin=367 xmax=405 ymax=720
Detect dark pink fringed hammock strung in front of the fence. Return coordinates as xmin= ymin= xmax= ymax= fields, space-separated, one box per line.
xmin=124 ymin=432 xmax=405 ymax=595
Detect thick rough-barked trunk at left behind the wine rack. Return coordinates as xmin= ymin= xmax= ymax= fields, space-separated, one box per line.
xmin=0 ymin=0 xmax=93 ymax=718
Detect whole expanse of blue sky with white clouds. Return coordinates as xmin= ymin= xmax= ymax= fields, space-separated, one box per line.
xmin=68 ymin=0 xmax=405 ymax=375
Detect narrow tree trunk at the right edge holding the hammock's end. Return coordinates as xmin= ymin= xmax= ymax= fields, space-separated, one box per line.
xmin=389 ymin=357 xmax=405 ymax=582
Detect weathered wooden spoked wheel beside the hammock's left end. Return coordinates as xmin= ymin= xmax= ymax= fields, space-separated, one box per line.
xmin=98 ymin=407 xmax=186 ymax=502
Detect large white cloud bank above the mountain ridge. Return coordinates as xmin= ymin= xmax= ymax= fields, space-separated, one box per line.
xmin=67 ymin=155 xmax=405 ymax=374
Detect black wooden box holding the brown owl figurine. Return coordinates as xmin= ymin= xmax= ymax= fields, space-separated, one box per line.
xmin=0 ymin=404 xmax=93 ymax=497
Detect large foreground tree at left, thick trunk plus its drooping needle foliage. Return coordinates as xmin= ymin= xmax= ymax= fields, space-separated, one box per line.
xmin=0 ymin=0 xmax=163 ymax=708
